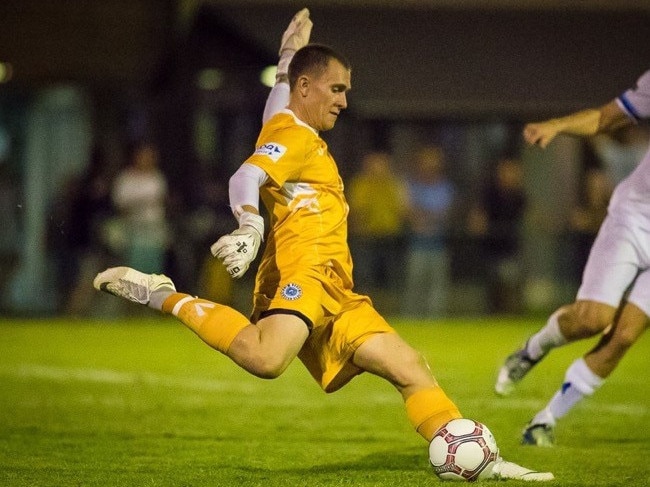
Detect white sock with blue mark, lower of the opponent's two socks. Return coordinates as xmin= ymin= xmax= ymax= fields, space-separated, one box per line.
xmin=546 ymin=358 xmax=605 ymax=419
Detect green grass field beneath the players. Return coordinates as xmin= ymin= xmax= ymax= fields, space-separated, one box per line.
xmin=0 ymin=315 xmax=650 ymax=487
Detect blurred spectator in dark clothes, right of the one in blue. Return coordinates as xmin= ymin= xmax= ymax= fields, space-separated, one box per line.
xmin=469 ymin=158 xmax=526 ymax=313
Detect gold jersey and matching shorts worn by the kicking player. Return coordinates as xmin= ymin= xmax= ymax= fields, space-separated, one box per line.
xmin=240 ymin=110 xmax=394 ymax=392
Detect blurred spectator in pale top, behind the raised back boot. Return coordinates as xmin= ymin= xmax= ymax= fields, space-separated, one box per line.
xmin=112 ymin=142 xmax=169 ymax=273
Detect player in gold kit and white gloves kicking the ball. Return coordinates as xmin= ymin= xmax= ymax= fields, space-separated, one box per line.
xmin=94 ymin=9 xmax=553 ymax=480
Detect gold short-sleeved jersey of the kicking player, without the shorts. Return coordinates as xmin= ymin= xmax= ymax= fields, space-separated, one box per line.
xmin=246 ymin=110 xmax=352 ymax=289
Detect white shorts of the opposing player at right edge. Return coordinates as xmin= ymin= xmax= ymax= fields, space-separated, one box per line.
xmin=577 ymin=216 xmax=650 ymax=316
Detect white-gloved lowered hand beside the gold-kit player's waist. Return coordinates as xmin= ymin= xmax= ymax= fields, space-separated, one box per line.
xmin=210 ymin=212 xmax=264 ymax=279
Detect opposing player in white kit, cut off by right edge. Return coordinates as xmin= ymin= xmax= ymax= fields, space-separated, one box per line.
xmin=495 ymin=70 xmax=650 ymax=446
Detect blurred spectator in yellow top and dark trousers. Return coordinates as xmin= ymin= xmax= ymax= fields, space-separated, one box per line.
xmin=347 ymin=152 xmax=407 ymax=301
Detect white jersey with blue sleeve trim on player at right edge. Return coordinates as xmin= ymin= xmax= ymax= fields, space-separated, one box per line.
xmin=609 ymin=70 xmax=650 ymax=230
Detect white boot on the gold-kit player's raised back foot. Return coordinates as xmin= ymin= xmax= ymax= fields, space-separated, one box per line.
xmin=93 ymin=267 xmax=176 ymax=304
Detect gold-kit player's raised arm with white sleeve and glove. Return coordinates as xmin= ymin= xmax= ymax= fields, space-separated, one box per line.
xmin=262 ymin=8 xmax=313 ymax=123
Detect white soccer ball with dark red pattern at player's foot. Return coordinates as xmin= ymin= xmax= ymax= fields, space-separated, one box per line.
xmin=429 ymin=418 xmax=499 ymax=482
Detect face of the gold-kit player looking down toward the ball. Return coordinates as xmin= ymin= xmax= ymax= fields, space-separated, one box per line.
xmin=298 ymin=59 xmax=351 ymax=131
